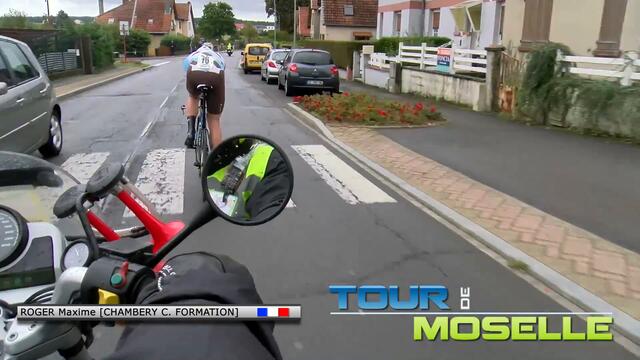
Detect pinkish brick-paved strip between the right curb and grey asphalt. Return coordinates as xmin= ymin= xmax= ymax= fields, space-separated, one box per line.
xmin=329 ymin=126 xmax=640 ymax=319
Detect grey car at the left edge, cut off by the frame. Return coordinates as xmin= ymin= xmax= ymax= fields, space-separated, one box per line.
xmin=0 ymin=36 xmax=62 ymax=157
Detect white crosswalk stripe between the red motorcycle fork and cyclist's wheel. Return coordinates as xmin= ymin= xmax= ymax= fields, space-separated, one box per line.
xmin=124 ymin=149 xmax=185 ymax=217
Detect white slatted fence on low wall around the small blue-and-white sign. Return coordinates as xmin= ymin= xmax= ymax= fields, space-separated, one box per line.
xmin=369 ymin=43 xmax=487 ymax=74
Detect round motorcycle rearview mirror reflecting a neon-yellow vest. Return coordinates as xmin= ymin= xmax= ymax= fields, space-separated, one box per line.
xmin=202 ymin=135 xmax=293 ymax=225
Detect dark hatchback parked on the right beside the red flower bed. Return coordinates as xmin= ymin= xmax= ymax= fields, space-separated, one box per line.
xmin=278 ymin=49 xmax=340 ymax=96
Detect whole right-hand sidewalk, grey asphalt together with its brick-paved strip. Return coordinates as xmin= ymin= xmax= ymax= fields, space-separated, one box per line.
xmin=292 ymin=81 xmax=640 ymax=341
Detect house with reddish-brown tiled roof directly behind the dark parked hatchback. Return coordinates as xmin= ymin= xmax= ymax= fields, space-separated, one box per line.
xmin=310 ymin=0 xmax=378 ymax=40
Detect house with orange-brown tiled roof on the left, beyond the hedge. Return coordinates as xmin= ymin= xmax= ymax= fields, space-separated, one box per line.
xmin=96 ymin=0 xmax=195 ymax=55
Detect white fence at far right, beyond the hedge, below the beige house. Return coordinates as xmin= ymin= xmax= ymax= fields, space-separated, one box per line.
xmin=557 ymin=50 xmax=640 ymax=86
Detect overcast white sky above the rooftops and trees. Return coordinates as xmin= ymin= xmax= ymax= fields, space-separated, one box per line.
xmin=0 ymin=0 xmax=267 ymax=20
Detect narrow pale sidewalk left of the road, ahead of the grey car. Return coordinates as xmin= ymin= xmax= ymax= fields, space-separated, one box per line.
xmin=53 ymin=63 xmax=148 ymax=99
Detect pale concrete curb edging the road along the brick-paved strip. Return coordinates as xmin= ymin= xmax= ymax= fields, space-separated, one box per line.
xmin=287 ymin=103 xmax=640 ymax=344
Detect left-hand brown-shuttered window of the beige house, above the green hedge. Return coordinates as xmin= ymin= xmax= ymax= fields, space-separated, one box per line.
xmin=520 ymin=0 xmax=553 ymax=51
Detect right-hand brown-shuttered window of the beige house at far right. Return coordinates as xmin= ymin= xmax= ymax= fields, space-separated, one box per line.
xmin=593 ymin=0 xmax=627 ymax=57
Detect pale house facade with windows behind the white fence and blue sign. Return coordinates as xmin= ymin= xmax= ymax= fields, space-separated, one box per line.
xmin=376 ymin=0 xmax=505 ymax=49
